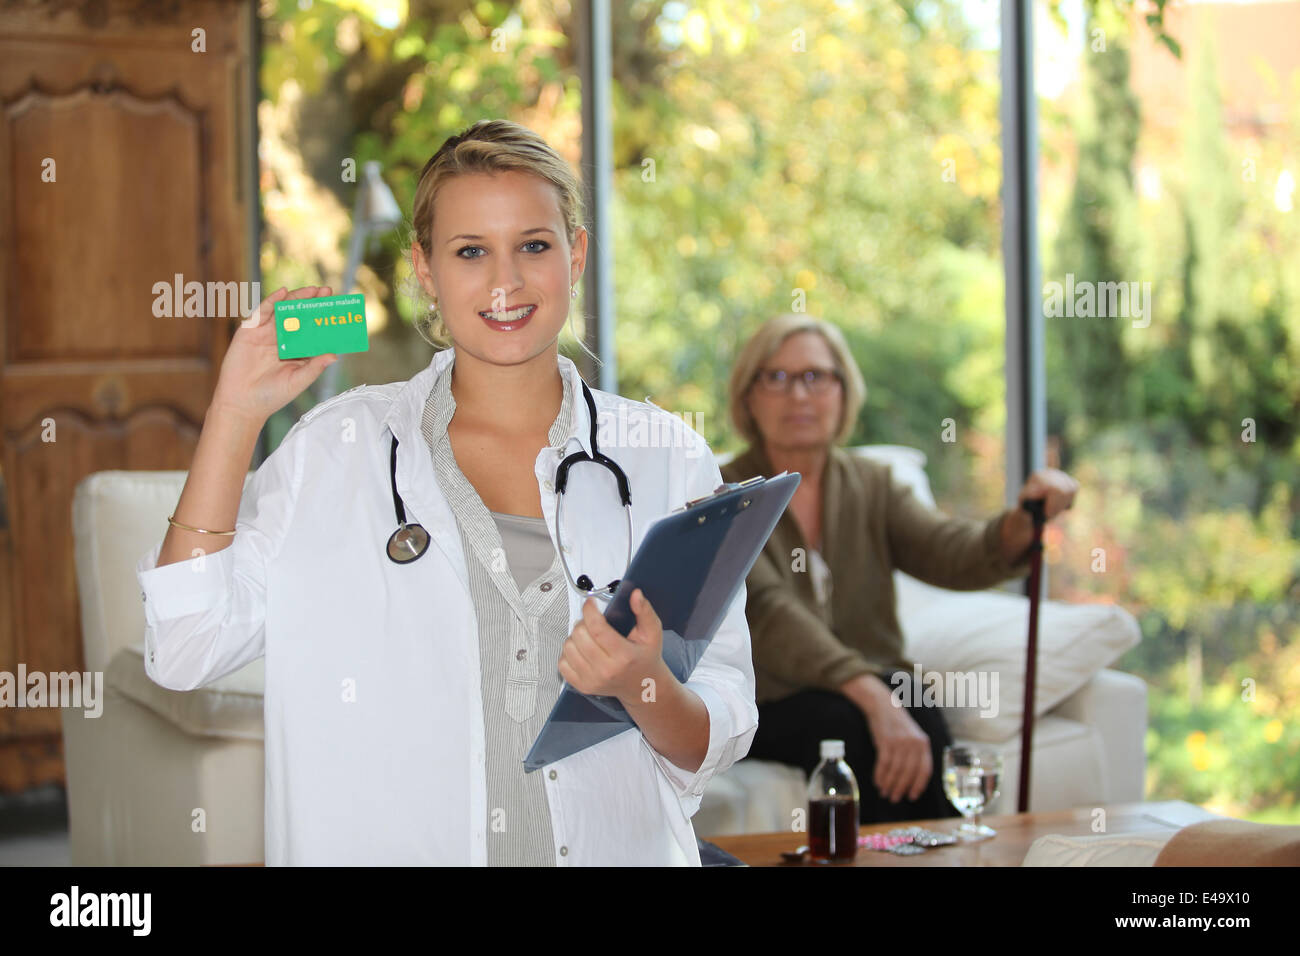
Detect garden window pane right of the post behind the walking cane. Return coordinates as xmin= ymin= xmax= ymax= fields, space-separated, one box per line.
xmin=1036 ymin=3 xmax=1300 ymax=822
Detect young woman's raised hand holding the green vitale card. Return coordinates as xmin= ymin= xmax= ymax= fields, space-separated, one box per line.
xmin=211 ymin=286 xmax=338 ymax=427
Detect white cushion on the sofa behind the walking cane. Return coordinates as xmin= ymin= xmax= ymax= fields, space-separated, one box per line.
xmin=894 ymin=572 xmax=1141 ymax=743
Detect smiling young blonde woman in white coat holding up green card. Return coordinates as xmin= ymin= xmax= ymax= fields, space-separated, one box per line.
xmin=139 ymin=121 xmax=758 ymax=866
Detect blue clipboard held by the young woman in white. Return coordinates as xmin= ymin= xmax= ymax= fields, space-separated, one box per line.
xmin=524 ymin=472 xmax=800 ymax=773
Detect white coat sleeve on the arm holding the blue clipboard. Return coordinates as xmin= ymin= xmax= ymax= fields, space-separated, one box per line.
xmin=642 ymin=436 xmax=758 ymax=817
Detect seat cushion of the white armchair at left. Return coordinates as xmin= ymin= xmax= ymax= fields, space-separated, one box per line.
xmin=104 ymin=645 xmax=265 ymax=740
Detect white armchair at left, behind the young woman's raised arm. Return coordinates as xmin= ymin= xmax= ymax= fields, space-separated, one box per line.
xmin=62 ymin=471 xmax=265 ymax=866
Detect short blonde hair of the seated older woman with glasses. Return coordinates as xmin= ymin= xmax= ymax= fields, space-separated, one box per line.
xmin=727 ymin=312 xmax=867 ymax=446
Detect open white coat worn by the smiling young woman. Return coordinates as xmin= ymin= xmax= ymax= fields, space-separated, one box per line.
xmin=137 ymin=350 xmax=758 ymax=866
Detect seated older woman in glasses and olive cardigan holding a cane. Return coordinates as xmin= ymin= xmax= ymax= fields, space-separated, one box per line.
xmin=723 ymin=315 xmax=1078 ymax=823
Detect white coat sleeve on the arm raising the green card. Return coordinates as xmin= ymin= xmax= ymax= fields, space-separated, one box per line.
xmin=135 ymin=421 xmax=304 ymax=691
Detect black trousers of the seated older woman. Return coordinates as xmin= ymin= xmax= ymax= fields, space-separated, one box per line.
xmin=748 ymin=671 xmax=961 ymax=823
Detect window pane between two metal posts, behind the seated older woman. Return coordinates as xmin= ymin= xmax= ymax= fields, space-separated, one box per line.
xmin=614 ymin=0 xmax=1005 ymax=514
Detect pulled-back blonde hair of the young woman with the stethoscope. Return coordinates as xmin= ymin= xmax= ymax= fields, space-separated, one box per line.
xmin=407 ymin=120 xmax=586 ymax=350
